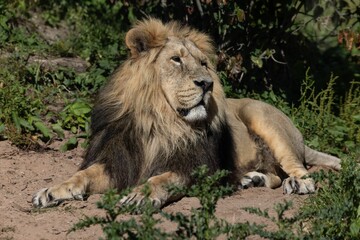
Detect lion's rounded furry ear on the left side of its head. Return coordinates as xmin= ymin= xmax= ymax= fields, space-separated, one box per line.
xmin=125 ymin=19 xmax=167 ymax=57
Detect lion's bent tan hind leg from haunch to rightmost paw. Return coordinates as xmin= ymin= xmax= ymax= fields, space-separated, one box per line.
xmin=233 ymin=99 xmax=315 ymax=194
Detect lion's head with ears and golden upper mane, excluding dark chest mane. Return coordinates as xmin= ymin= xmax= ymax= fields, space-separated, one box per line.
xmin=94 ymin=19 xmax=225 ymax=153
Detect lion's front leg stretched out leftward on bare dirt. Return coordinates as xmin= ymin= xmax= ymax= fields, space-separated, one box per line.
xmin=32 ymin=164 xmax=111 ymax=208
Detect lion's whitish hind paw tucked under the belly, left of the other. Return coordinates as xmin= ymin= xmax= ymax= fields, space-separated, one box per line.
xmin=240 ymin=171 xmax=281 ymax=188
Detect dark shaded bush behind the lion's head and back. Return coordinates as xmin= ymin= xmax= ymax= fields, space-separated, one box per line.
xmin=123 ymin=0 xmax=360 ymax=103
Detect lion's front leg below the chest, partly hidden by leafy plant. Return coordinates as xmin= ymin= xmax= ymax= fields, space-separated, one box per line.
xmin=120 ymin=172 xmax=188 ymax=208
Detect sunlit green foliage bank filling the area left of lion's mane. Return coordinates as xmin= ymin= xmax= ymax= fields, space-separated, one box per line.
xmin=0 ymin=0 xmax=130 ymax=150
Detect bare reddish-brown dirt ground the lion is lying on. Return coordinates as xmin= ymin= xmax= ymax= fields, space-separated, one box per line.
xmin=0 ymin=141 xmax=306 ymax=240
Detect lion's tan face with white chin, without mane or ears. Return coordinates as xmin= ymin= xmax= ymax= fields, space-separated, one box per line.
xmin=156 ymin=37 xmax=214 ymax=122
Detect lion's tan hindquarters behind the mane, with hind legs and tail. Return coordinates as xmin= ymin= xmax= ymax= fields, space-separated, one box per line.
xmin=227 ymin=98 xmax=341 ymax=194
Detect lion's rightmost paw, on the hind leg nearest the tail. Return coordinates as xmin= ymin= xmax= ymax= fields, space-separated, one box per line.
xmin=282 ymin=177 xmax=315 ymax=194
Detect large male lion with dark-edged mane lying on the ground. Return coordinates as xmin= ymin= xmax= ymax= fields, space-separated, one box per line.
xmin=32 ymin=18 xmax=341 ymax=208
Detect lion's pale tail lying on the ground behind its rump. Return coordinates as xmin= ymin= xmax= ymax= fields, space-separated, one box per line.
xmin=305 ymin=146 xmax=341 ymax=170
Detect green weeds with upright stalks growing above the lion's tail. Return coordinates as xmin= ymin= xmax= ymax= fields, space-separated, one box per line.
xmin=292 ymin=71 xmax=360 ymax=155
